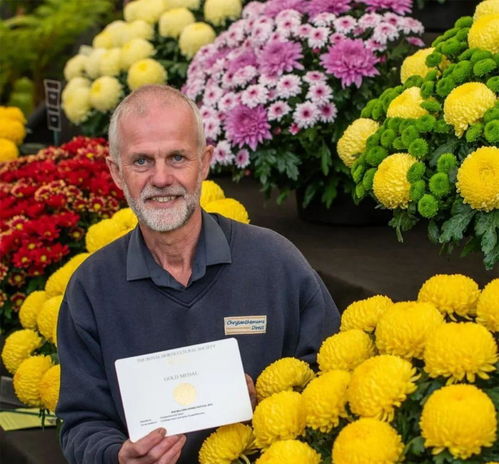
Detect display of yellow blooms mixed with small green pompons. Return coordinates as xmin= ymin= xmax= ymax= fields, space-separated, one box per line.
xmin=338 ymin=0 xmax=499 ymax=268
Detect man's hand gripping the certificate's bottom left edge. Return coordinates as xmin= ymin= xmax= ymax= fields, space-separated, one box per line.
xmin=118 ymin=428 xmax=186 ymax=464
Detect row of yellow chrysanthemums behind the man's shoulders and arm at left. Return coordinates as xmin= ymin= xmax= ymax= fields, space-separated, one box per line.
xmin=1 ymin=181 xmax=249 ymax=411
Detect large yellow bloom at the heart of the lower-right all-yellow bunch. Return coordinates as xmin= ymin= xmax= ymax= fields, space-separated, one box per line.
xmin=347 ymin=354 xmax=418 ymax=422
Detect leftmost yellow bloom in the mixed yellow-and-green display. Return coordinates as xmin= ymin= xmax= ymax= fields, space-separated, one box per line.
xmin=336 ymin=118 xmax=379 ymax=168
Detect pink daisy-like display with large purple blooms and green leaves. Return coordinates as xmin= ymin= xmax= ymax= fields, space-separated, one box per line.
xmin=183 ymin=0 xmax=422 ymax=204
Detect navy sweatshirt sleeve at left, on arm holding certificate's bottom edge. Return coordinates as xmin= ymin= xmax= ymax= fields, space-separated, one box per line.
xmin=56 ymin=285 xmax=127 ymax=464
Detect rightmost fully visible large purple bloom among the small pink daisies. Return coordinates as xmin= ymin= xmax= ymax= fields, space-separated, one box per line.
xmin=321 ymin=39 xmax=379 ymax=87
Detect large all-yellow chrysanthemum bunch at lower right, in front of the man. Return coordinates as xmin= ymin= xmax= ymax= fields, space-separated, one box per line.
xmin=199 ymin=274 xmax=499 ymax=464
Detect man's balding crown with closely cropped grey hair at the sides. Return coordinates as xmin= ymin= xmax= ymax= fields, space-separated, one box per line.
xmin=109 ymin=85 xmax=206 ymax=161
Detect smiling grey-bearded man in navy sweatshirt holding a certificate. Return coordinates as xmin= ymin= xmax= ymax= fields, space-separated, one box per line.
xmin=57 ymin=86 xmax=339 ymax=464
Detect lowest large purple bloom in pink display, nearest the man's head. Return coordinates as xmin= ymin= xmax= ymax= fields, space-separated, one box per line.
xmin=225 ymin=105 xmax=272 ymax=150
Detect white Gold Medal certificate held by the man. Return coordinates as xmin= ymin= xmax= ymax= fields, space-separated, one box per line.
xmin=115 ymin=338 xmax=253 ymax=441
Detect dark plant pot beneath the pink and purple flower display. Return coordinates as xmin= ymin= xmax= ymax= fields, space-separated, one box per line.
xmin=296 ymin=190 xmax=391 ymax=226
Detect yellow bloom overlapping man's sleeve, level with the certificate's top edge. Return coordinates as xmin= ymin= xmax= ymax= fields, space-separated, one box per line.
xmin=317 ymin=329 xmax=374 ymax=372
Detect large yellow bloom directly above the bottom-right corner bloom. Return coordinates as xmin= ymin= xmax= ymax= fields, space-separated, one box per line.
xmin=423 ymin=322 xmax=497 ymax=383
